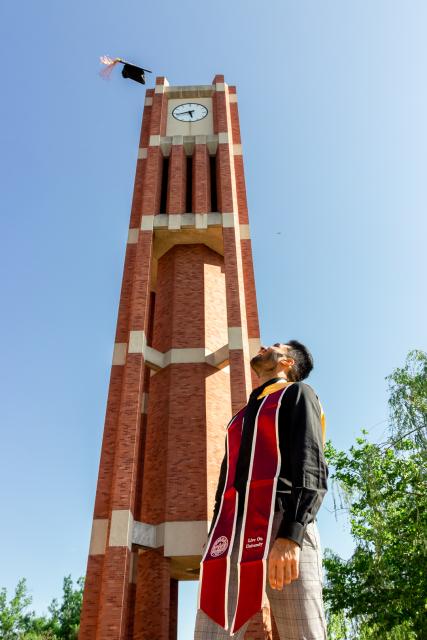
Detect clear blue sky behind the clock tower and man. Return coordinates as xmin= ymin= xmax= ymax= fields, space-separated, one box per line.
xmin=0 ymin=0 xmax=427 ymax=640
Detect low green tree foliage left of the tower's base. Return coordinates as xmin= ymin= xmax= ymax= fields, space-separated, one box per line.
xmin=0 ymin=576 xmax=84 ymax=640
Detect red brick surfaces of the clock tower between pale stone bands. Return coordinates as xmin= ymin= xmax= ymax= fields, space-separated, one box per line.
xmin=79 ymin=75 xmax=271 ymax=640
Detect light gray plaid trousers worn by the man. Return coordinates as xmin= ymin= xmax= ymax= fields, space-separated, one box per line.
xmin=194 ymin=511 xmax=326 ymax=640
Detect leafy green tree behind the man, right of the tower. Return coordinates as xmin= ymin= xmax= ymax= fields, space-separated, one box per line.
xmin=324 ymin=351 xmax=427 ymax=640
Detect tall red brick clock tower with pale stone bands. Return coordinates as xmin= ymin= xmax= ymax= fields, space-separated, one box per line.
xmin=79 ymin=75 xmax=270 ymax=640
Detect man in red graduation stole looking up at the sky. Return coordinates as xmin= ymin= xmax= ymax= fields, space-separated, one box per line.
xmin=194 ymin=340 xmax=328 ymax=640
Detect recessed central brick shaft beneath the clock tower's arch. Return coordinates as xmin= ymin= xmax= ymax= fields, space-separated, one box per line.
xmin=141 ymin=244 xmax=230 ymax=528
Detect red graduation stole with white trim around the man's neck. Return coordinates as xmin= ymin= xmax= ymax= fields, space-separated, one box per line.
xmin=199 ymin=383 xmax=292 ymax=635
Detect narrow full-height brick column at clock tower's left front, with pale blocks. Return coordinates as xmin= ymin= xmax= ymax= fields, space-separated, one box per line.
xmin=88 ymin=80 xmax=167 ymax=640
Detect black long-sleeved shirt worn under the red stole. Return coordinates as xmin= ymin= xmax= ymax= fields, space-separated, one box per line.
xmin=210 ymin=378 xmax=329 ymax=547
